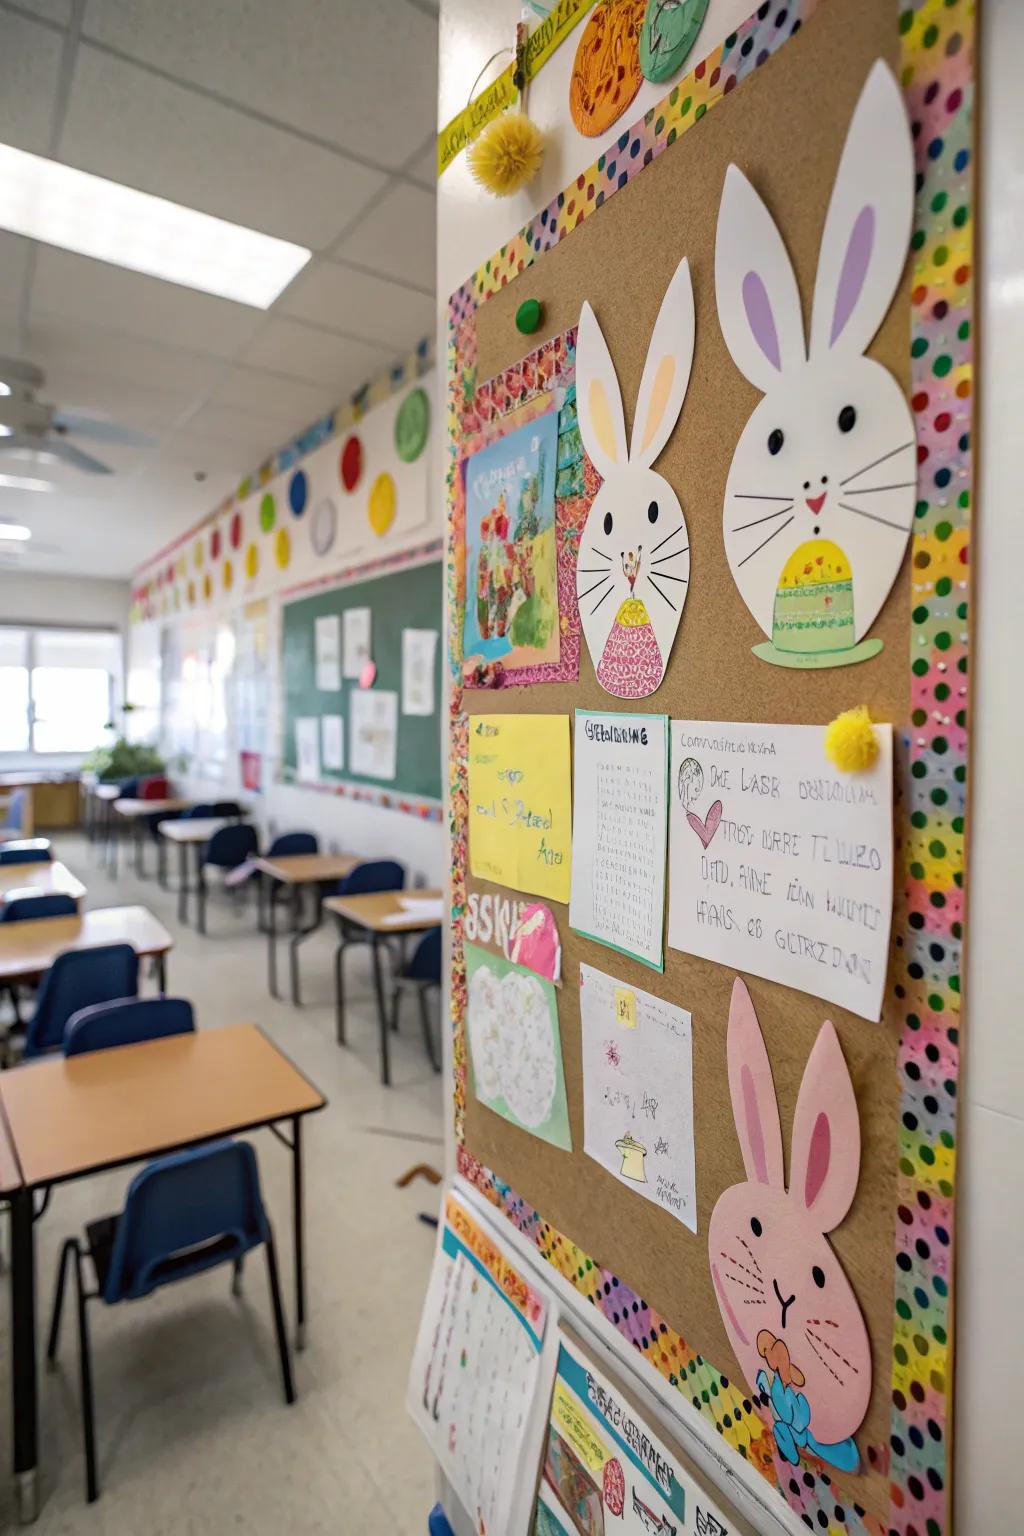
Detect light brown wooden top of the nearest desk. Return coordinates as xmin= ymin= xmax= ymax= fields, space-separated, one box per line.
xmin=0 ymin=1025 xmax=325 ymax=1184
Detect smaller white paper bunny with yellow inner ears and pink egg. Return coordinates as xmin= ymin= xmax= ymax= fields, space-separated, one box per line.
xmin=576 ymin=260 xmax=694 ymax=699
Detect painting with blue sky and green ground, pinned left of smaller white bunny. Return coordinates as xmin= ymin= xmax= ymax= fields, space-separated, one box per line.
xmin=464 ymin=410 xmax=559 ymax=667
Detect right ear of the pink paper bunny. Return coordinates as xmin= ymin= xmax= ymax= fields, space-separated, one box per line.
xmin=789 ymin=1021 xmax=860 ymax=1232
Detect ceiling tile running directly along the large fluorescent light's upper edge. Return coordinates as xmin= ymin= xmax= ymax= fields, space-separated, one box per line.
xmin=60 ymin=45 xmax=385 ymax=250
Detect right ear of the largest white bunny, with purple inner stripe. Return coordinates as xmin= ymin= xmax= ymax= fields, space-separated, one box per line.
xmin=811 ymin=58 xmax=913 ymax=358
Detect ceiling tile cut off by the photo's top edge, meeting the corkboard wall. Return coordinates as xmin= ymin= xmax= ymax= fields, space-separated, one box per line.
xmin=77 ymin=0 xmax=438 ymax=169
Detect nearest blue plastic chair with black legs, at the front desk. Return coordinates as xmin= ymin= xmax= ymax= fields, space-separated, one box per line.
xmin=46 ymin=1141 xmax=295 ymax=1504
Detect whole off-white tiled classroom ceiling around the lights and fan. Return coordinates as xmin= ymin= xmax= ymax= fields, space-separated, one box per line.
xmin=0 ymin=0 xmax=438 ymax=576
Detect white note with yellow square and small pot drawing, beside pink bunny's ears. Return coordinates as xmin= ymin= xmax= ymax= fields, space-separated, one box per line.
xmin=580 ymin=965 xmax=697 ymax=1232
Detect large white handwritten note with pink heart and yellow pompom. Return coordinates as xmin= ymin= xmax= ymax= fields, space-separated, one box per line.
xmin=668 ymin=720 xmax=892 ymax=1020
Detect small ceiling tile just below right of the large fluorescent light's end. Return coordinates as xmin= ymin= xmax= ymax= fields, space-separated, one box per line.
xmin=279 ymin=261 xmax=434 ymax=352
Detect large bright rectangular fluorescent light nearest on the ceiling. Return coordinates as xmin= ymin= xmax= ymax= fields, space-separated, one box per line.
xmin=0 ymin=144 xmax=312 ymax=309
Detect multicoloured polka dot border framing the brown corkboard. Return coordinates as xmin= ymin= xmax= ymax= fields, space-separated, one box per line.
xmin=445 ymin=0 xmax=975 ymax=1536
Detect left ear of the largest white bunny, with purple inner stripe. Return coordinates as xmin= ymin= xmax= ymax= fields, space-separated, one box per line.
xmin=715 ymin=166 xmax=808 ymax=393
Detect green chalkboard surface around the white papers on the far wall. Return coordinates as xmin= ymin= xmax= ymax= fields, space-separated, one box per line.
xmin=281 ymin=561 xmax=444 ymax=800
